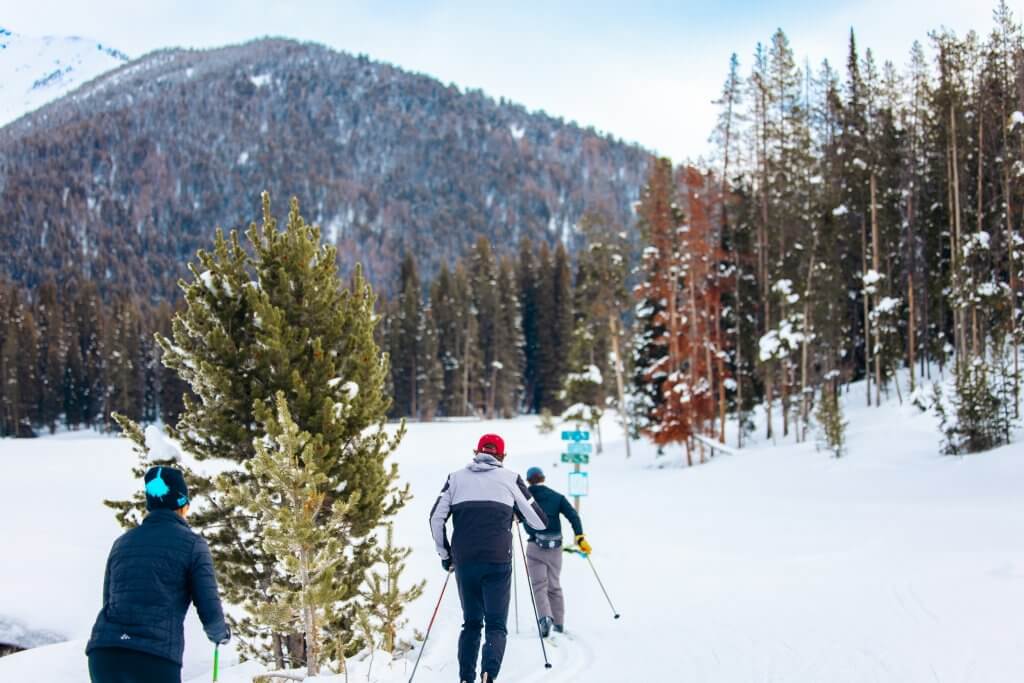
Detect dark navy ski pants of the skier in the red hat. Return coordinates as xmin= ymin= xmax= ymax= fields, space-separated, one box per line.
xmin=455 ymin=562 xmax=512 ymax=681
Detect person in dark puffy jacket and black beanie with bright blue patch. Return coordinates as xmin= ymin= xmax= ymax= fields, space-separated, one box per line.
xmin=85 ymin=467 xmax=230 ymax=683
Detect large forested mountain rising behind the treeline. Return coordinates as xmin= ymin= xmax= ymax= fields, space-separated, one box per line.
xmin=0 ymin=40 xmax=649 ymax=297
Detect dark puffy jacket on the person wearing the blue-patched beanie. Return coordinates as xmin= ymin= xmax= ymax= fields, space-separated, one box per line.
xmin=85 ymin=510 xmax=228 ymax=666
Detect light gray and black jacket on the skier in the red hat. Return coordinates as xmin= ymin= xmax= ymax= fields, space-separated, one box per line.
xmin=430 ymin=453 xmax=548 ymax=565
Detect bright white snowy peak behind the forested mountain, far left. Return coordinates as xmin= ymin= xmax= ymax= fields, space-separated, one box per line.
xmin=0 ymin=27 xmax=128 ymax=126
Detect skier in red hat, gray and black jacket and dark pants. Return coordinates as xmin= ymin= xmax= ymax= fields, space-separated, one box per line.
xmin=430 ymin=434 xmax=548 ymax=683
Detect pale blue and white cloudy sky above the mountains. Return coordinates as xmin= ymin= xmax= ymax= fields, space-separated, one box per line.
xmin=0 ymin=0 xmax=1003 ymax=161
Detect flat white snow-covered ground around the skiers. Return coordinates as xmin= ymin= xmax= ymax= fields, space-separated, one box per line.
xmin=0 ymin=376 xmax=1024 ymax=683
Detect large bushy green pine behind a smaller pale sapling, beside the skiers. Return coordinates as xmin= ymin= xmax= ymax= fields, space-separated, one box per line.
xmin=108 ymin=193 xmax=408 ymax=668
